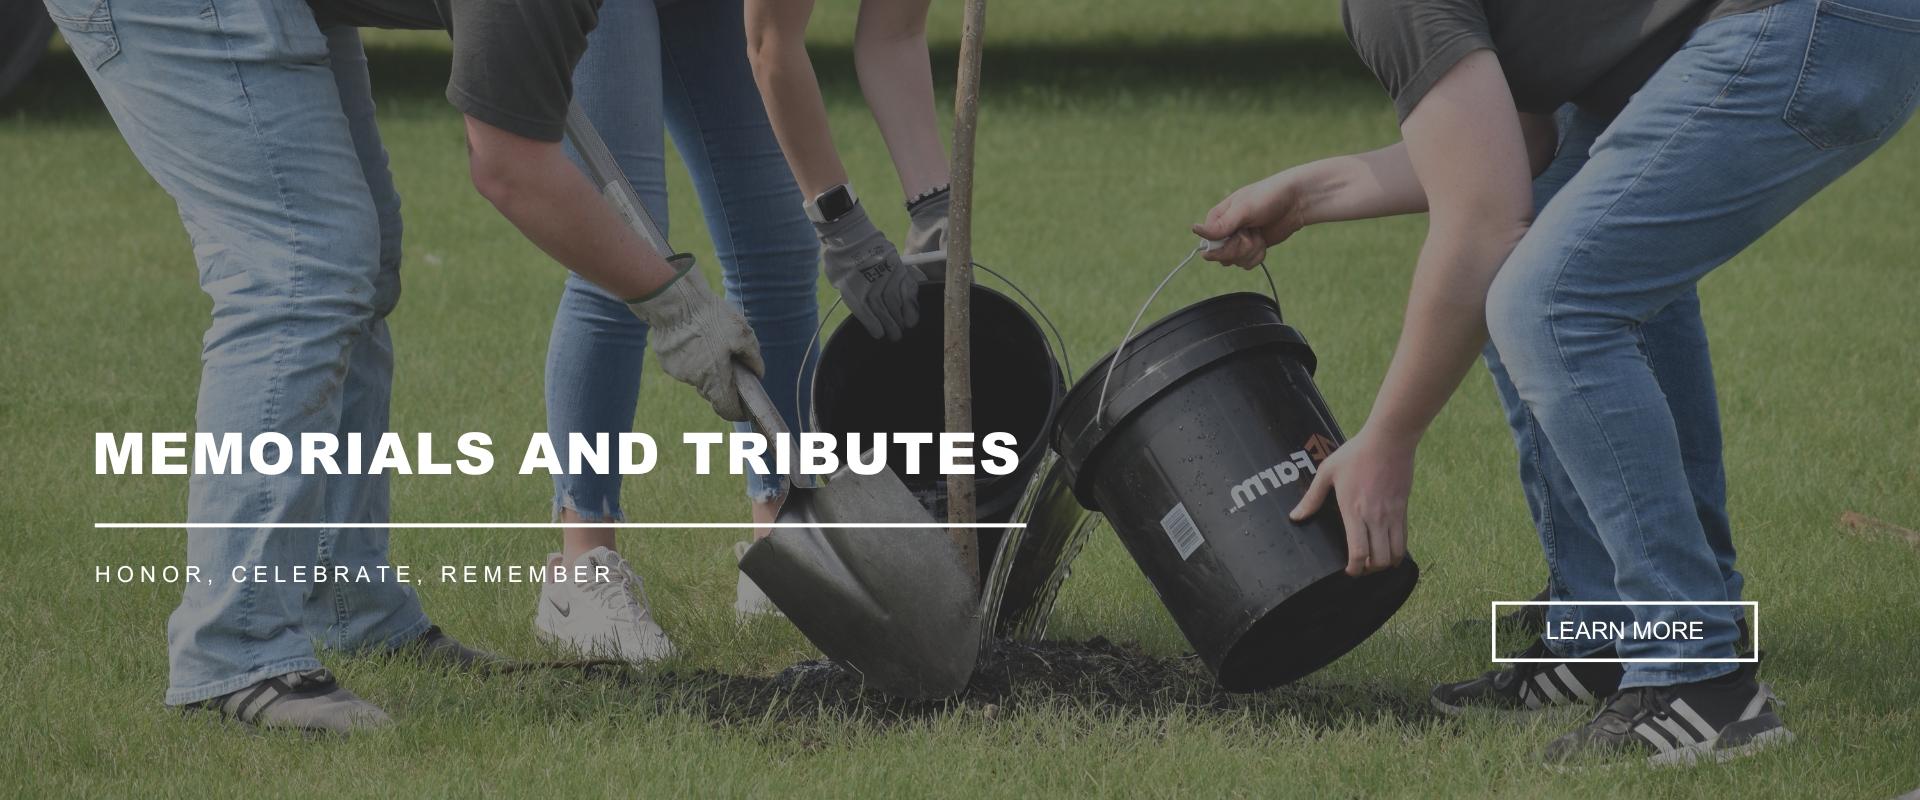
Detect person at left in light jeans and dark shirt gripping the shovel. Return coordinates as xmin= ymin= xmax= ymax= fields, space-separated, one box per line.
xmin=48 ymin=0 xmax=760 ymax=733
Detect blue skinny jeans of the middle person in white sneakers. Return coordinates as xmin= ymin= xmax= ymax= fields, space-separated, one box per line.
xmin=547 ymin=0 xmax=820 ymax=522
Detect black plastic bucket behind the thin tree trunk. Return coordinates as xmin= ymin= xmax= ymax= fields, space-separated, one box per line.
xmin=812 ymin=282 xmax=1066 ymax=541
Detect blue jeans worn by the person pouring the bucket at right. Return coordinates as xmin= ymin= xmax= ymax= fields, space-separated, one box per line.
xmin=1486 ymin=0 xmax=1920 ymax=687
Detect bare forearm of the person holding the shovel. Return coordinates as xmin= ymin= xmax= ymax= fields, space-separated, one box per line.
xmin=467 ymin=117 xmax=676 ymax=299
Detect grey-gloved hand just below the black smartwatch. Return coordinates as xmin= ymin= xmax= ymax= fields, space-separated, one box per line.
xmin=814 ymin=203 xmax=925 ymax=341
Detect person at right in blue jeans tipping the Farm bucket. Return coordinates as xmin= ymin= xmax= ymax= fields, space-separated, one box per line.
xmin=1194 ymin=0 xmax=1920 ymax=764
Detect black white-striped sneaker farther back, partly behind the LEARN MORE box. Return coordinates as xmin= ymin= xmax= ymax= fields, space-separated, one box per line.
xmin=1430 ymin=639 xmax=1624 ymax=714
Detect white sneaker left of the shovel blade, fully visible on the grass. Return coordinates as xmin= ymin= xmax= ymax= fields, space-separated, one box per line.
xmin=534 ymin=547 xmax=674 ymax=664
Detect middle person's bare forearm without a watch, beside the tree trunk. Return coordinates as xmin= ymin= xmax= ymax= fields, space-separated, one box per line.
xmin=852 ymin=0 xmax=947 ymax=198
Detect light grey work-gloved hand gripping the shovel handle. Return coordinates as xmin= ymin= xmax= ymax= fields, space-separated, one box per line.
xmin=626 ymin=253 xmax=766 ymax=422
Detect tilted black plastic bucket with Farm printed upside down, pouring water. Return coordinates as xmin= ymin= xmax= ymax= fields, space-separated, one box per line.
xmin=1054 ymin=294 xmax=1419 ymax=691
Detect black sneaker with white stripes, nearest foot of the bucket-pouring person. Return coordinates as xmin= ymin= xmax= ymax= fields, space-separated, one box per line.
xmin=1542 ymin=664 xmax=1793 ymax=767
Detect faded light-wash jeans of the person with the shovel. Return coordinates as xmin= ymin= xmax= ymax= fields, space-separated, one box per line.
xmin=46 ymin=0 xmax=428 ymax=704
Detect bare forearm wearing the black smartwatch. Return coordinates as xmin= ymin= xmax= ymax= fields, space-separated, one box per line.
xmin=747 ymin=0 xmax=847 ymax=198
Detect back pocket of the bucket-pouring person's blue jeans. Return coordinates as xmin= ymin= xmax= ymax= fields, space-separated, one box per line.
xmin=1782 ymin=0 xmax=1920 ymax=150
